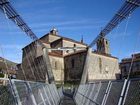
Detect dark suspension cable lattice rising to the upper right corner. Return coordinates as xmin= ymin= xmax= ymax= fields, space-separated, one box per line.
xmin=89 ymin=0 xmax=140 ymax=48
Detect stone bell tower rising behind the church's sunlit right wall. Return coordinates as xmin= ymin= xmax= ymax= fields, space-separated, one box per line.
xmin=96 ymin=37 xmax=110 ymax=54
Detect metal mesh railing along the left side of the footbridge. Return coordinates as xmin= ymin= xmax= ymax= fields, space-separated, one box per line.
xmin=0 ymin=79 xmax=61 ymax=105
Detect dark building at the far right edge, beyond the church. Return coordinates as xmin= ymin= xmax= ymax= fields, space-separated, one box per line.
xmin=120 ymin=53 xmax=140 ymax=78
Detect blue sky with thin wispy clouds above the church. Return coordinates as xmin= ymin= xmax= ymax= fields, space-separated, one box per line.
xmin=0 ymin=0 xmax=140 ymax=63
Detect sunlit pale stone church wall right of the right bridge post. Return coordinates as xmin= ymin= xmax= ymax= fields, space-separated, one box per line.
xmin=88 ymin=53 xmax=119 ymax=81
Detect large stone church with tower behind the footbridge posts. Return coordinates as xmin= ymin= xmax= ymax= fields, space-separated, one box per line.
xmin=17 ymin=29 xmax=119 ymax=83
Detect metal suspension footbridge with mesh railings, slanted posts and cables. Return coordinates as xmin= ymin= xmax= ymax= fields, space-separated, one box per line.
xmin=0 ymin=0 xmax=140 ymax=105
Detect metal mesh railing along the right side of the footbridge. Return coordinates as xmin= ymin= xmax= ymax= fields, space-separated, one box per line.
xmin=74 ymin=78 xmax=140 ymax=105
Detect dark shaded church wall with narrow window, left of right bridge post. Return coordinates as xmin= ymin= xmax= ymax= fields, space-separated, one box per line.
xmin=64 ymin=51 xmax=86 ymax=82
